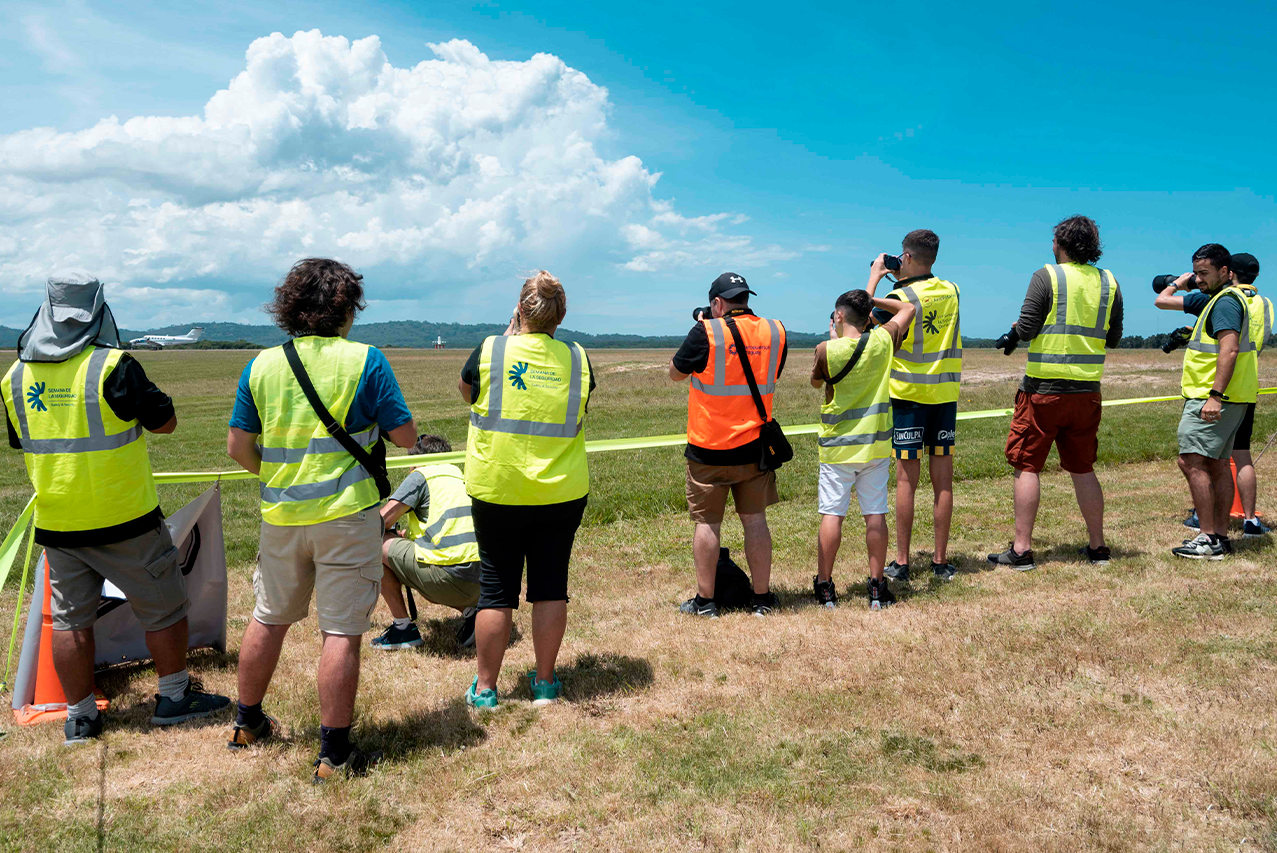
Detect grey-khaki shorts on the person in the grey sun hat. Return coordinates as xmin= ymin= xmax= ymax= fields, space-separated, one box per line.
xmin=45 ymin=521 xmax=190 ymax=631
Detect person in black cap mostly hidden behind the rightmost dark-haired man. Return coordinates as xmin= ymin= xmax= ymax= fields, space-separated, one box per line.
xmin=1153 ymin=252 xmax=1273 ymax=539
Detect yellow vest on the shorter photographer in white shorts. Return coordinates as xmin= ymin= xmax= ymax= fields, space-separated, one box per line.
xmin=817 ymin=327 xmax=894 ymax=464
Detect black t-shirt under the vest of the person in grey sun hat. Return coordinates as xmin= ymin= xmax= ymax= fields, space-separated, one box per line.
xmin=5 ymin=354 xmax=174 ymax=548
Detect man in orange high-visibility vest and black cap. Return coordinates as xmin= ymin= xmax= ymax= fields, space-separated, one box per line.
xmin=669 ymin=272 xmax=788 ymax=618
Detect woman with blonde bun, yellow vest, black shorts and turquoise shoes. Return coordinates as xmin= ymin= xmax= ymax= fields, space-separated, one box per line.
xmin=457 ymin=269 xmax=595 ymax=709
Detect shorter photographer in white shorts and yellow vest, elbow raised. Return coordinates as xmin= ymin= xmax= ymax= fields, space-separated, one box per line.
xmin=811 ymin=290 xmax=914 ymax=610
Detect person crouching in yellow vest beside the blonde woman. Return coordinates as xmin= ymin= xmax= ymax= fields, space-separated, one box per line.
xmin=373 ymin=435 xmax=479 ymax=651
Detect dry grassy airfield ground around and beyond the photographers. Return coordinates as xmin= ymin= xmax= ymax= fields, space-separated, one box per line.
xmin=0 ymin=350 xmax=1277 ymax=852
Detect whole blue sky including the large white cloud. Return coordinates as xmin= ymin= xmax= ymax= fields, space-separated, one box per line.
xmin=0 ymin=3 xmax=1277 ymax=336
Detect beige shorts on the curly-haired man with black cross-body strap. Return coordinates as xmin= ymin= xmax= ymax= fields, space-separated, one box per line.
xmin=253 ymin=508 xmax=382 ymax=636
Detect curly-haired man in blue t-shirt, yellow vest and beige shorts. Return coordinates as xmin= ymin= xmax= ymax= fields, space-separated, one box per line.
xmin=226 ymin=258 xmax=416 ymax=781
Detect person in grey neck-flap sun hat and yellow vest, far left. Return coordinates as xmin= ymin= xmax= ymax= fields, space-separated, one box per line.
xmin=3 ymin=271 xmax=230 ymax=746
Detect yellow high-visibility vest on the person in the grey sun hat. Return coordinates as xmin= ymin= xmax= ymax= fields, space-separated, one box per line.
xmin=4 ymin=346 xmax=160 ymax=531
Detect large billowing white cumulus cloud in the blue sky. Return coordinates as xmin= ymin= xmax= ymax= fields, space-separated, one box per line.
xmin=0 ymin=31 xmax=796 ymax=323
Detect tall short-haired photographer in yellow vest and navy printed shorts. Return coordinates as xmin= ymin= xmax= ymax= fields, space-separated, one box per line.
xmin=866 ymin=229 xmax=962 ymax=581
